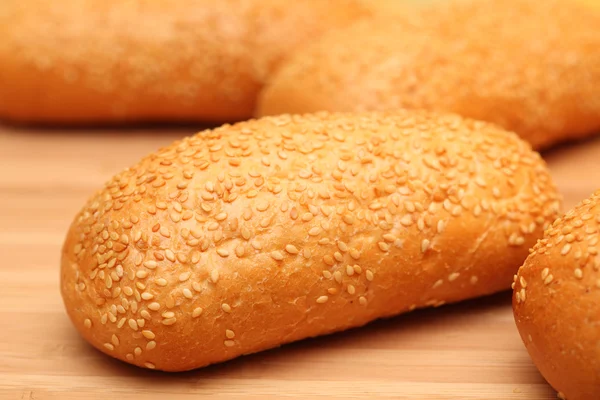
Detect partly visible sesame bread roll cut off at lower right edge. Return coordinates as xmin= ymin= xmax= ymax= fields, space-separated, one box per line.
xmin=513 ymin=191 xmax=600 ymax=400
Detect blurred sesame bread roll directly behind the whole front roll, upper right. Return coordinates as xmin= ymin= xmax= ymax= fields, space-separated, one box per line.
xmin=258 ymin=0 xmax=600 ymax=149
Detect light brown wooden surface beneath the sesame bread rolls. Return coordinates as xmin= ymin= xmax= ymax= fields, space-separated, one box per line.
xmin=0 ymin=127 xmax=600 ymax=400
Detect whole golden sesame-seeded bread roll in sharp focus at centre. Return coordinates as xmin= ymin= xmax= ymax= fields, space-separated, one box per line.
xmin=61 ymin=111 xmax=559 ymax=371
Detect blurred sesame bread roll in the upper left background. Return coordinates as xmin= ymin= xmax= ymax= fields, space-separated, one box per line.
xmin=0 ymin=0 xmax=368 ymax=124
